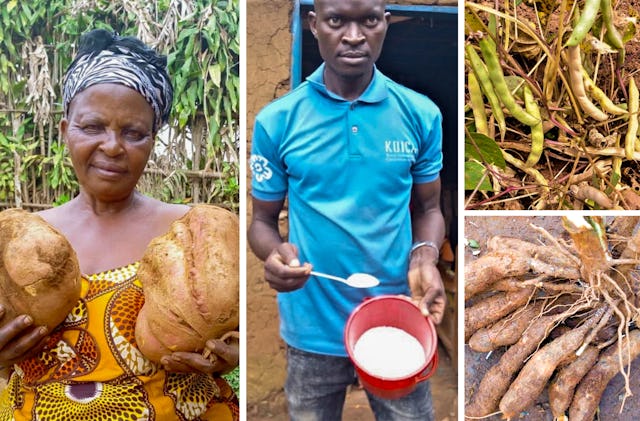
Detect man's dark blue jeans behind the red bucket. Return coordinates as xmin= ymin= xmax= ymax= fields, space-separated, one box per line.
xmin=285 ymin=347 xmax=434 ymax=421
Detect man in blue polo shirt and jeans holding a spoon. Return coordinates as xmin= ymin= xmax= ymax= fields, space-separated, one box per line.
xmin=249 ymin=0 xmax=445 ymax=421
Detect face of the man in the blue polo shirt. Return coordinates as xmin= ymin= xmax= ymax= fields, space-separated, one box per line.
xmin=309 ymin=0 xmax=390 ymax=78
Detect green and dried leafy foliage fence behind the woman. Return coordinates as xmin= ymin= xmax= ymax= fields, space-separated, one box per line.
xmin=0 ymin=0 xmax=239 ymax=212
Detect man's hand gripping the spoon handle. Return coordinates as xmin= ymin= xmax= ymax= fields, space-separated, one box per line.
xmin=264 ymin=243 xmax=311 ymax=292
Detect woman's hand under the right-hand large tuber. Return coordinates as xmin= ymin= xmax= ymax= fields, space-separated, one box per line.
xmin=160 ymin=331 xmax=240 ymax=374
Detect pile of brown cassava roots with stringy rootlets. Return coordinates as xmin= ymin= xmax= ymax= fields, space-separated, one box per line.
xmin=464 ymin=216 xmax=640 ymax=421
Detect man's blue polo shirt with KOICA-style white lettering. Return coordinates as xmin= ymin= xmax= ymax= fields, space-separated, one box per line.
xmin=250 ymin=64 xmax=442 ymax=356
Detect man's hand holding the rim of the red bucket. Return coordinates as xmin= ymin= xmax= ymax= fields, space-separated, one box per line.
xmin=408 ymin=247 xmax=446 ymax=324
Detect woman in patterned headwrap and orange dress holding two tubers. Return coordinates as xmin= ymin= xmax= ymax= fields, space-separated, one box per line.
xmin=0 ymin=30 xmax=238 ymax=421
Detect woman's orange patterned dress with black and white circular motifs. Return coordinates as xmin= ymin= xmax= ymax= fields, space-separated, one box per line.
xmin=0 ymin=263 xmax=239 ymax=421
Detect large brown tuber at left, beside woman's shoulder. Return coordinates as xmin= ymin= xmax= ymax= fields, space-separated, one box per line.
xmin=0 ymin=209 xmax=80 ymax=330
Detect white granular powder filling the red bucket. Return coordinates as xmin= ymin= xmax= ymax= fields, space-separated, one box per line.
xmin=353 ymin=326 xmax=426 ymax=379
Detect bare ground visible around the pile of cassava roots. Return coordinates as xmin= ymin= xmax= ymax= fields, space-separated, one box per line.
xmin=464 ymin=216 xmax=640 ymax=421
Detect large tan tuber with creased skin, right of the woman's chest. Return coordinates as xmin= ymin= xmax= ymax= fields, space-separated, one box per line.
xmin=136 ymin=205 xmax=240 ymax=362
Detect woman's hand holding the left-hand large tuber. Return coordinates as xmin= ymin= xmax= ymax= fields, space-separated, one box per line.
xmin=0 ymin=305 xmax=47 ymax=368
